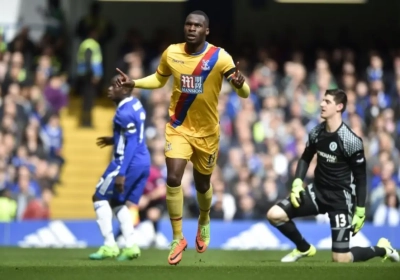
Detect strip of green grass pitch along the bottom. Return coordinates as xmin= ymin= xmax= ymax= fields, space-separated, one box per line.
xmin=0 ymin=248 xmax=400 ymax=280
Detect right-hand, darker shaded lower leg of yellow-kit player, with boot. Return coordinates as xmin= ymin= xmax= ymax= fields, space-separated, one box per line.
xmin=193 ymin=169 xmax=213 ymax=253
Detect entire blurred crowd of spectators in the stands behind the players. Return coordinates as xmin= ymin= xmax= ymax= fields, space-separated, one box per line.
xmin=0 ymin=1 xmax=400 ymax=226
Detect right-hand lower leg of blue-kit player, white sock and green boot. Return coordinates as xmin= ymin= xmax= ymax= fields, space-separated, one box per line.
xmin=113 ymin=202 xmax=141 ymax=261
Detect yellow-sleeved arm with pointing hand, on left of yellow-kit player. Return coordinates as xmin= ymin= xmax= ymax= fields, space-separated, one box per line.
xmin=116 ymin=68 xmax=168 ymax=89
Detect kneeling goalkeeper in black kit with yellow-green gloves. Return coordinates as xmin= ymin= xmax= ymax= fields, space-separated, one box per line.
xmin=267 ymin=89 xmax=399 ymax=262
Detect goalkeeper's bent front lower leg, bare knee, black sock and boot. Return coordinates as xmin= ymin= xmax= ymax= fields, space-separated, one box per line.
xmin=267 ymin=206 xmax=317 ymax=262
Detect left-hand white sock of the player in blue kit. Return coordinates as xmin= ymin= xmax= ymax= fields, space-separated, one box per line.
xmin=93 ymin=200 xmax=116 ymax=246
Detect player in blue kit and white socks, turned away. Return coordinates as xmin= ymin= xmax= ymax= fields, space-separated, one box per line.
xmin=89 ymin=77 xmax=151 ymax=260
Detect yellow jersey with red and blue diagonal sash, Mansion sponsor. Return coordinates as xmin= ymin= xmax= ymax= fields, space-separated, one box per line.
xmin=157 ymin=42 xmax=235 ymax=137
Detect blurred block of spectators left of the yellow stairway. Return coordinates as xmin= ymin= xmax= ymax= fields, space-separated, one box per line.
xmin=0 ymin=1 xmax=70 ymax=221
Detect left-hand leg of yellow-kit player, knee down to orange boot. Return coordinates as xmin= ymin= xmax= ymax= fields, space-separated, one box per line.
xmin=166 ymin=157 xmax=187 ymax=265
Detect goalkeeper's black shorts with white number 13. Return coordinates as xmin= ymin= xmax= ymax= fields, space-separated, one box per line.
xmin=277 ymin=184 xmax=354 ymax=253
